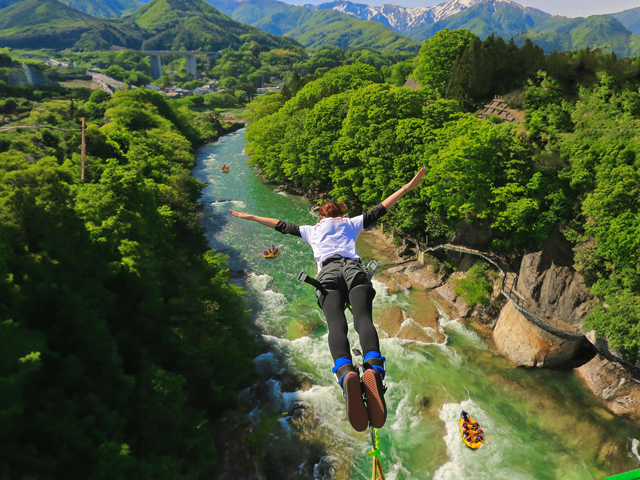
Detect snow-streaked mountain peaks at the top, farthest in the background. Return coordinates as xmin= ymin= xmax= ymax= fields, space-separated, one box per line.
xmin=305 ymin=0 xmax=527 ymax=33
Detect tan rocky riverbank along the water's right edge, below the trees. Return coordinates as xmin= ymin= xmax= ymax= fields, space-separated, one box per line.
xmin=370 ymin=229 xmax=640 ymax=426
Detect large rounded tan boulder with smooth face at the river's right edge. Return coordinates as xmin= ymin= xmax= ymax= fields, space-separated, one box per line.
xmin=493 ymin=302 xmax=584 ymax=367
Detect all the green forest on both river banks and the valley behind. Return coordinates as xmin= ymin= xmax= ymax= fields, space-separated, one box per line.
xmin=0 ymin=24 xmax=640 ymax=480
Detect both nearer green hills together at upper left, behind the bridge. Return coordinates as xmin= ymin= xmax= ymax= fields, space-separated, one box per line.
xmin=0 ymin=0 xmax=297 ymax=51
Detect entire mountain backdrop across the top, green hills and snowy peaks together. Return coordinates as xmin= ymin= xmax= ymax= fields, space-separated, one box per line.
xmin=0 ymin=0 xmax=640 ymax=56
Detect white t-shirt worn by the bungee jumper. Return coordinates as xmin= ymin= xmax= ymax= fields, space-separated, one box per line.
xmin=300 ymin=215 xmax=364 ymax=272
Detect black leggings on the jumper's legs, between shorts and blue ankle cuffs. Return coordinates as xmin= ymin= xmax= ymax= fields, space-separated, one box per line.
xmin=318 ymin=279 xmax=380 ymax=361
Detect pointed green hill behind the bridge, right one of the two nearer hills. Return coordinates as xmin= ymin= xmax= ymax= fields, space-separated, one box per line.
xmin=124 ymin=0 xmax=296 ymax=51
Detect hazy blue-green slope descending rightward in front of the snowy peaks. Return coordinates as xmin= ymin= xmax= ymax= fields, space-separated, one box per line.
xmin=209 ymin=0 xmax=420 ymax=53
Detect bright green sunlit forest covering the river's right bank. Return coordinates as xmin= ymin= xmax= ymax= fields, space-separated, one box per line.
xmin=247 ymin=30 xmax=640 ymax=361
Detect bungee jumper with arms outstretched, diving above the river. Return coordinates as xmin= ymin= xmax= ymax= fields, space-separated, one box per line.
xmin=230 ymin=167 xmax=425 ymax=434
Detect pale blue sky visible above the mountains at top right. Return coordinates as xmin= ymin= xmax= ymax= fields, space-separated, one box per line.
xmin=283 ymin=0 xmax=640 ymax=17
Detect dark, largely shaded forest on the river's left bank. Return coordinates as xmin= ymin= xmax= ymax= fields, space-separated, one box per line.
xmin=0 ymin=85 xmax=256 ymax=480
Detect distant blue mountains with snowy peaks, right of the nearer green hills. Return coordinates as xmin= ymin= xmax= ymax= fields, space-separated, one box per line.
xmin=207 ymin=0 xmax=640 ymax=56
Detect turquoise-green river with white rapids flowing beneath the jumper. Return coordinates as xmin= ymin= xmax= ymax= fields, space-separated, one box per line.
xmin=193 ymin=130 xmax=640 ymax=480
